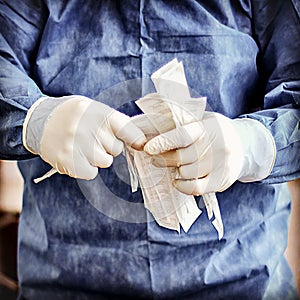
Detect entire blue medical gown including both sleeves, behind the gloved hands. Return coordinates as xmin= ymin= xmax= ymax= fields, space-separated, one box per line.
xmin=0 ymin=0 xmax=300 ymax=299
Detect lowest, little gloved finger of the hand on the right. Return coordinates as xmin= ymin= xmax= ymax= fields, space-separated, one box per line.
xmin=173 ymin=175 xmax=216 ymax=196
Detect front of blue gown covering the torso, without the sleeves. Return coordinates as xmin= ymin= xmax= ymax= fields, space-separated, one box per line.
xmin=19 ymin=1 xmax=288 ymax=299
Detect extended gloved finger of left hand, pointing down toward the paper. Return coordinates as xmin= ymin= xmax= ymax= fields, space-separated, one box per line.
xmin=108 ymin=110 xmax=147 ymax=150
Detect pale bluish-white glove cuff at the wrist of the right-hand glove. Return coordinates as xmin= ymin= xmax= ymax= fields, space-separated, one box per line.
xmin=233 ymin=118 xmax=276 ymax=182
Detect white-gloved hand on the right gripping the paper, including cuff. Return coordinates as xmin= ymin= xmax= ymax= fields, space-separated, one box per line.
xmin=144 ymin=112 xmax=276 ymax=195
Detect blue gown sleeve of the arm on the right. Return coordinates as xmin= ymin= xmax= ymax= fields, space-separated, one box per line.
xmin=241 ymin=0 xmax=300 ymax=183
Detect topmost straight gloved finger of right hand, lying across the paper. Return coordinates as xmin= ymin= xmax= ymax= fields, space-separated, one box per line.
xmin=144 ymin=122 xmax=204 ymax=155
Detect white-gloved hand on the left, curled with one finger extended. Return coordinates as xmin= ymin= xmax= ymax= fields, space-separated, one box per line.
xmin=23 ymin=95 xmax=146 ymax=179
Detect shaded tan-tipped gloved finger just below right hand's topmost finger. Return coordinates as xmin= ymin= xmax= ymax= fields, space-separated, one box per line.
xmin=152 ymin=144 xmax=198 ymax=167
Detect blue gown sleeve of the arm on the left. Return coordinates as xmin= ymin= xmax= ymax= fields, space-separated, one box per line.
xmin=0 ymin=0 xmax=47 ymax=160
